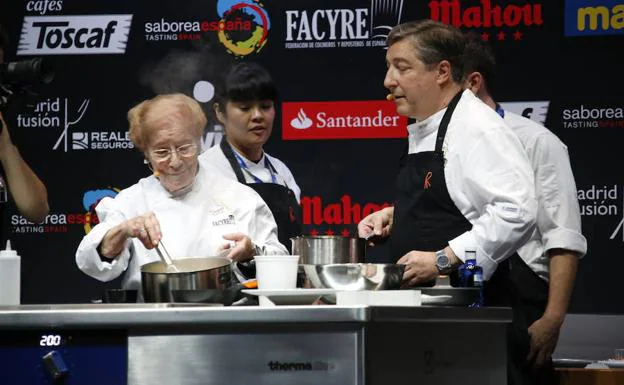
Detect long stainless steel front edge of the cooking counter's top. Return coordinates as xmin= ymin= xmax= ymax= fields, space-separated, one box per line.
xmin=0 ymin=303 xmax=511 ymax=330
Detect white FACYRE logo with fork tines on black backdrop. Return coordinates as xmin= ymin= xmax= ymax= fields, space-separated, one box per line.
xmin=284 ymin=0 xmax=403 ymax=49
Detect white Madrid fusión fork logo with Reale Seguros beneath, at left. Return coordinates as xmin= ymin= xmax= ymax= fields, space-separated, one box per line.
xmin=16 ymin=97 xmax=134 ymax=152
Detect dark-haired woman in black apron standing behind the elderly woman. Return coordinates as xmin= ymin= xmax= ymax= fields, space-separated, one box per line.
xmin=200 ymin=62 xmax=302 ymax=252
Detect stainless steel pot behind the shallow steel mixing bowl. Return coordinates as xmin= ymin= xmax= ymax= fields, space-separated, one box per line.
xmin=290 ymin=235 xmax=366 ymax=265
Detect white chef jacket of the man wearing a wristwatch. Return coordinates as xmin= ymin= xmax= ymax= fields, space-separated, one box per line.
xmin=408 ymin=90 xmax=537 ymax=279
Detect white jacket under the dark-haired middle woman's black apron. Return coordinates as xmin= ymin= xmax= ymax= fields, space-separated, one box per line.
xmin=199 ymin=138 xmax=301 ymax=202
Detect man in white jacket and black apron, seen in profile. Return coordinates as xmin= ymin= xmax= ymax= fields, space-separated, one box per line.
xmin=358 ymin=20 xmax=537 ymax=384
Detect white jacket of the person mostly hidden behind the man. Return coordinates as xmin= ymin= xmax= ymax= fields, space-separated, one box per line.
xmin=504 ymin=111 xmax=587 ymax=281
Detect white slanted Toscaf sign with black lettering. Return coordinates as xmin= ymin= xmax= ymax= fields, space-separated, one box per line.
xmin=17 ymin=15 xmax=132 ymax=55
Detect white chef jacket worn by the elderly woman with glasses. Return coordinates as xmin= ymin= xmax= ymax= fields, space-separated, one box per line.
xmin=76 ymin=166 xmax=288 ymax=290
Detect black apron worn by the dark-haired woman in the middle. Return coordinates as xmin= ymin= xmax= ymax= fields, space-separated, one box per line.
xmin=220 ymin=138 xmax=302 ymax=253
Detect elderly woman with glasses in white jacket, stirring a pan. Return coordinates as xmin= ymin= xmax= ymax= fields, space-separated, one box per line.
xmin=76 ymin=94 xmax=288 ymax=290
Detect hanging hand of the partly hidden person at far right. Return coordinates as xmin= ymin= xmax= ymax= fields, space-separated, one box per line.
xmin=527 ymin=316 xmax=562 ymax=369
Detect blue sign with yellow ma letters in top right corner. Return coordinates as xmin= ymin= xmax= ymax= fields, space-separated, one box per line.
xmin=564 ymin=0 xmax=624 ymax=36
